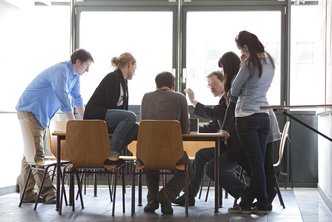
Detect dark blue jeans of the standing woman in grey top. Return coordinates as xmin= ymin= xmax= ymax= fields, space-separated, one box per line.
xmin=235 ymin=113 xmax=270 ymax=209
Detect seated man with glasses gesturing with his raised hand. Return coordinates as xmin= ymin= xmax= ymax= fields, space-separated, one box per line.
xmin=173 ymin=71 xmax=246 ymax=206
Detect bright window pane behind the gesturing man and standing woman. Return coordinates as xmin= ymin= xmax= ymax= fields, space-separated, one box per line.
xmin=186 ymin=11 xmax=281 ymax=105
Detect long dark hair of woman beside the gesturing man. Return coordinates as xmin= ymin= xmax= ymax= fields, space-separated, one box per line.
xmin=218 ymin=52 xmax=241 ymax=93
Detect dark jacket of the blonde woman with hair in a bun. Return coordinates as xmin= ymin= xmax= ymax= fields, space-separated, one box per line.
xmin=83 ymin=69 xmax=128 ymax=119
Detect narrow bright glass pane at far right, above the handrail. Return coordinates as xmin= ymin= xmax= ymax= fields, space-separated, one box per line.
xmin=290 ymin=5 xmax=325 ymax=105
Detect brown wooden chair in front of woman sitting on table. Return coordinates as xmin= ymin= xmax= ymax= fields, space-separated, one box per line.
xmin=59 ymin=120 xmax=125 ymax=216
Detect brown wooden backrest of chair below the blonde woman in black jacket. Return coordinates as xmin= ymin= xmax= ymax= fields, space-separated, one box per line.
xmin=64 ymin=120 xmax=111 ymax=168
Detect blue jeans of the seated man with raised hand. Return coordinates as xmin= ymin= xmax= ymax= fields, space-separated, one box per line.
xmin=189 ymin=147 xmax=246 ymax=198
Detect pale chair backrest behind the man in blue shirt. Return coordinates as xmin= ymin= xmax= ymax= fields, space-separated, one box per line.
xmin=19 ymin=119 xmax=36 ymax=164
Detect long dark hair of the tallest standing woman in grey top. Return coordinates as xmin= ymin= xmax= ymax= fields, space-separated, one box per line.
xmin=235 ymin=31 xmax=274 ymax=77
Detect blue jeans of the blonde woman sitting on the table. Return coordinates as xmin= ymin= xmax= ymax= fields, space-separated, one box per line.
xmin=105 ymin=109 xmax=138 ymax=154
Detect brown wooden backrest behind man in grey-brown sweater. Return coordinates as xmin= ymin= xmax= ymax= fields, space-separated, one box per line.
xmin=136 ymin=120 xmax=184 ymax=169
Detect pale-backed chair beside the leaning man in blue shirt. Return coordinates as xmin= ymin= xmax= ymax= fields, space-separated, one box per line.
xmin=18 ymin=119 xmax=69 ymax=210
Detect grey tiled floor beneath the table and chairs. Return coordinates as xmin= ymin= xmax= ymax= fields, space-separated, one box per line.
xmin=0 ymin=187 xmax=332 ymax=222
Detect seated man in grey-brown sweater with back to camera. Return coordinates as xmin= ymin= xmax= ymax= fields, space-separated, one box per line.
xmin=141 ymin=72 xmax=189 ymax=214
